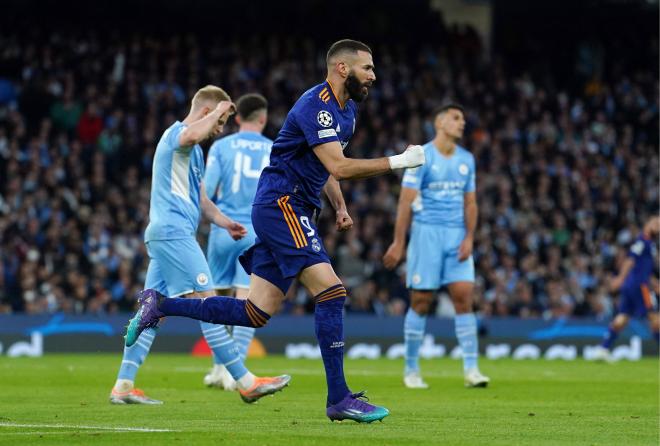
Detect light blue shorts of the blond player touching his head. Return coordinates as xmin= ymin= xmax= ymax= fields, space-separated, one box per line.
xmin=144 ymin=237 xmax=215 ymax=297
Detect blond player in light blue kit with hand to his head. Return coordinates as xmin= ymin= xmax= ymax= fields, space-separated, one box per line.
xmin=110 ymin=85 xmax=290 ymax=404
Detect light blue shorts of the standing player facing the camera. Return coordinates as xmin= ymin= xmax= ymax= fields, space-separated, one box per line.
xmin=406 ymin=223 xmax=474 ymax=290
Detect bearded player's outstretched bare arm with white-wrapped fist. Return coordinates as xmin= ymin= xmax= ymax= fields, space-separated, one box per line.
xmin=314 ymin=141 xmax=424 ymax=181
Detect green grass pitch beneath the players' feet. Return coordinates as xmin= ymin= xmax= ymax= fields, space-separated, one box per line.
xmin=0 ymin=354 xmax=659 ymax=446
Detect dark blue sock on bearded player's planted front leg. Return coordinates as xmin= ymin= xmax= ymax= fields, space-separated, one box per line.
xmin=314 ymin=284 xmax=350 ymax=406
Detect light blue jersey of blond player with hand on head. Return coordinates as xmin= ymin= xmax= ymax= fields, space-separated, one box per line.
xmin=144 ymin=121 xmax=204 ymax=242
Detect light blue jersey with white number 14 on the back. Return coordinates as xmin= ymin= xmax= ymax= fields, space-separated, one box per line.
xmin=204 ymin=132 xmax=273 ymax=223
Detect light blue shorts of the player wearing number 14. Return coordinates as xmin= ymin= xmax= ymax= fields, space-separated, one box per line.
xmin=207 ymin=223 xmax=257 ymax=289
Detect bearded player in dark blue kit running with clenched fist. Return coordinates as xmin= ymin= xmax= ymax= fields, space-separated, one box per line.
xmin=126 ymin=40 xmax=424 ymax=422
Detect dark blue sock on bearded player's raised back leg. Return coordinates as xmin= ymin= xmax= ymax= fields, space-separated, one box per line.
xmin=158 ymin=296 xmax=270 ymax=327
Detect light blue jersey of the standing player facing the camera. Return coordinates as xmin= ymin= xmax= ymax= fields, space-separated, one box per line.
xmin=402 ymin=141 xmax=476 ymax=228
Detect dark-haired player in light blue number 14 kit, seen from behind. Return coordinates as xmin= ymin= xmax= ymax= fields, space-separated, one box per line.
xmin=202 ymin=94 xmax=273 ymax=390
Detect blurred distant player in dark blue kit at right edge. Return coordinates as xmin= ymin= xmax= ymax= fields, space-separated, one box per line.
xmin=596 ymin=217 xmax=660 ymax=361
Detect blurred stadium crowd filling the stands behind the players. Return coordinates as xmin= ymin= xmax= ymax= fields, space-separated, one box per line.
xmin=0 ymin=27 xmax=660 ymax=318
